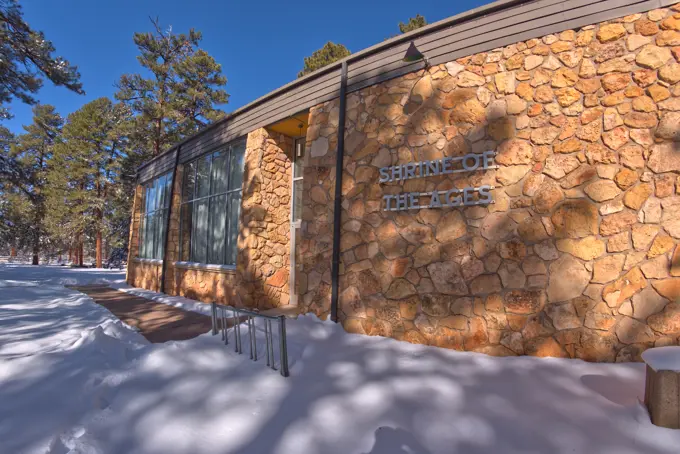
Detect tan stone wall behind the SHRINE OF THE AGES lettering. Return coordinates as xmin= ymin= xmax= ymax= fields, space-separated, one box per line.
xmin=306 ymin=5 xmax=680 ymax=361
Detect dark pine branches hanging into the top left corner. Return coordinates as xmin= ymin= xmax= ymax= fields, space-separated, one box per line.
xmin=0 ymin=0 xmax=85 ymax=118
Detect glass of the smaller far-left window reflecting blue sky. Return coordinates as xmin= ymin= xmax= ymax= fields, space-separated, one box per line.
xmin=138 ymin=173 xmax=172 ymax=259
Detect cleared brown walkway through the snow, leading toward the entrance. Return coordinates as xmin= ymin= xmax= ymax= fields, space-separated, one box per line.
xmin=69 ymin=285 xmax=212 ymax=343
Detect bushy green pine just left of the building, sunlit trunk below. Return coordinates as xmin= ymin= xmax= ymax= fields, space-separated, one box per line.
xmin=46 ymin=98 xmax=130 ymax=268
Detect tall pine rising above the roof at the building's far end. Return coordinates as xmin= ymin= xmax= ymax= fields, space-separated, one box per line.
xmin=116 ymin=20 xmax=229 ymax=161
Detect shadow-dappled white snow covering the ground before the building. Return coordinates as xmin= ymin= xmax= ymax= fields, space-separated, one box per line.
xmin=0 ymin=265 xmax=680 ymax=454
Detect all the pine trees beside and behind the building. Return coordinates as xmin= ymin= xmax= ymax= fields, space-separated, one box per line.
xmin=0 ymin=0 xmax=427 ymax=266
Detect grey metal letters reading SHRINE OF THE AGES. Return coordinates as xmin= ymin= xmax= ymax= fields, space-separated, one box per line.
xmin=379 ymin=151 xmax=498 ymax=211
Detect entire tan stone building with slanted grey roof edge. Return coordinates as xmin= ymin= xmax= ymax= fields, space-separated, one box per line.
xmin=127 ymin=0 xmax=680 ymax=362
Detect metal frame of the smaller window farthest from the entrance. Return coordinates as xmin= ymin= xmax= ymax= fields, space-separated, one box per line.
xmin=136 ymin=172 xmax=172 ymax=261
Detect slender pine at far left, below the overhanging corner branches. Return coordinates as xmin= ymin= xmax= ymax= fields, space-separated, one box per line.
xmin=5 ymin=104 xmax=63 ymax=265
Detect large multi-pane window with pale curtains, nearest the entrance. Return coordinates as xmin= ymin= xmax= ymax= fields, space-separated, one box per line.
xmin=180 ymin=140 xmax=246 ymax=265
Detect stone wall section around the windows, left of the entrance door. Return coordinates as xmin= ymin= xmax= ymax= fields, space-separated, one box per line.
xmin=128 ymin=129 xmax=293 ymax=309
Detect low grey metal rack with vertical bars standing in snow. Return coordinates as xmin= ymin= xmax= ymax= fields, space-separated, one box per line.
xmin=210 ymin=302 xmax=290 ymax=377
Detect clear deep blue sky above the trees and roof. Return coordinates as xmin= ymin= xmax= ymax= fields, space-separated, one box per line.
xmin=3 ymin=0 xmax=489 ymax=133
